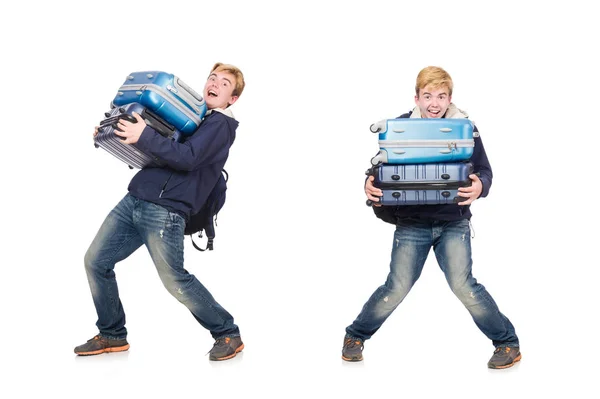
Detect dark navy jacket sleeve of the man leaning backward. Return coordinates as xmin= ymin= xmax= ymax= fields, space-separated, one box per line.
xmin=137 ymin=117 xmax=231 ymax=171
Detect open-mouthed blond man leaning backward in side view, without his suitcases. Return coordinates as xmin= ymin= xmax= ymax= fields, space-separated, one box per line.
xmin=75 ymin=63 xmax=245 ymax=360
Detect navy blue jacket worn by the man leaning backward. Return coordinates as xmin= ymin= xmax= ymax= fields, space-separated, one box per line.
xmin=128 ymin=111 xmax=238 ymax=221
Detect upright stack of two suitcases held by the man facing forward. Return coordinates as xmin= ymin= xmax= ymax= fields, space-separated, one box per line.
xmin=367 ymin=118 xmax=474 ymax=206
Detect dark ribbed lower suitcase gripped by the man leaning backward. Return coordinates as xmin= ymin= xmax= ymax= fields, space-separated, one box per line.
xmin=94 ymin=103 xmax=184 ymax=169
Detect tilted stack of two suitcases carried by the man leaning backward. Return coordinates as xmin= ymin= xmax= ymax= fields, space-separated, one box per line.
xmin=94 ymin=71 xmax=207 ymax=169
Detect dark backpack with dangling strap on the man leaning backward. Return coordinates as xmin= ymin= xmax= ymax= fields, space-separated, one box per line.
xmin=184 ymin=169 xmax=229 ymax=252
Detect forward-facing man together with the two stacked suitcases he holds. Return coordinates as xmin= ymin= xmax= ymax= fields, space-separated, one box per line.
xmin=342 ymin=67 xmax=521 ymax=369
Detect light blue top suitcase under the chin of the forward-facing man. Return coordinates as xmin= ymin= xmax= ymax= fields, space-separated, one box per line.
xmin=371 ymin=118 xmax=475 ymax=165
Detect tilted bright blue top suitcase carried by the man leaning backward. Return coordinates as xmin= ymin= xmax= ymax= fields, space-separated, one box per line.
xmin=112 ymin=71 xmax=207 ymax=135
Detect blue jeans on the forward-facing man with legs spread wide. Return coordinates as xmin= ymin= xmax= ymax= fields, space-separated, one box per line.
xmin=346 ymin=220 xmax=519 ymax=347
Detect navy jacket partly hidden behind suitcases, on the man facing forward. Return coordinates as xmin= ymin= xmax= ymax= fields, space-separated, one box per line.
xmin=373 ymin=111 xmax=493 ymax=224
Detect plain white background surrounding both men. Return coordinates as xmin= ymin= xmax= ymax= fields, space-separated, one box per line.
xmin=0 ymin=0 xmax=600 ymax=398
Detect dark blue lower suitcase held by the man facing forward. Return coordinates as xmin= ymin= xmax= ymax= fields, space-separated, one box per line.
xmin=367 ymin=162 xmax=473 ymax=205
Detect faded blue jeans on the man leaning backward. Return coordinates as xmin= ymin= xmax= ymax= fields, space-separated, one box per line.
xmin=85 ymin=194 xmax=240 ymax=339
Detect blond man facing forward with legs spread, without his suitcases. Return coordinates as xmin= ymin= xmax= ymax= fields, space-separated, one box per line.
xmin=342 ymin=67 xmax=521 ymax=368
